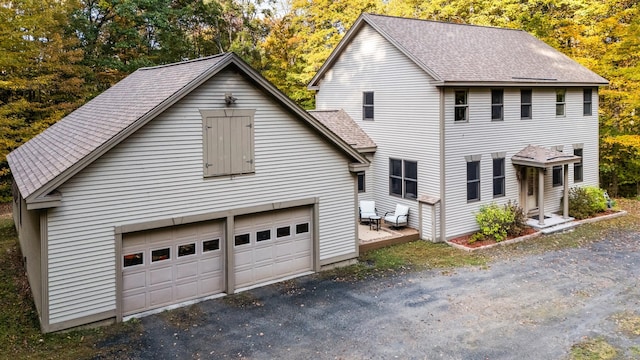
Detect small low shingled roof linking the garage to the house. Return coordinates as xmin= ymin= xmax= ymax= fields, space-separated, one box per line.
xmin=309 ymin=109 xmax=377 ymax=153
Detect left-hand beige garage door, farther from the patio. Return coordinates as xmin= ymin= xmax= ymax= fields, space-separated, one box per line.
xmin=122 ymin=221 xmax=224 ymax=315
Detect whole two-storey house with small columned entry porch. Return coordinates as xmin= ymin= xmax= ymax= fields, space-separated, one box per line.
xmin=308 ymin=14 xmax=607 ymax=241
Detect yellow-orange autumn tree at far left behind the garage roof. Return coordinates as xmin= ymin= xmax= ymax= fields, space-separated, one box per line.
xmin=0 ymin=0 xmax=87 ymax=201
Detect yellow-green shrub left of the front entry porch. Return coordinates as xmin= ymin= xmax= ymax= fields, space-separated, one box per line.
xmin=476 ymin=201 xmax=526 ymax=241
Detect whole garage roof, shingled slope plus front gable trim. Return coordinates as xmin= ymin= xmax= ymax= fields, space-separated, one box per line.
xmin=7 ymin=53 xmax=368 ymax=208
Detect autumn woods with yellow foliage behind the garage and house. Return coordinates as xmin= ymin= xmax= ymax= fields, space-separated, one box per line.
xmin=0 ymin=0 xmax=640 ymax=202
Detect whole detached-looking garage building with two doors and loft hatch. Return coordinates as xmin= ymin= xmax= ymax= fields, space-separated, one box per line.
xmin=8 ymin=54 xmax=369 ymax=332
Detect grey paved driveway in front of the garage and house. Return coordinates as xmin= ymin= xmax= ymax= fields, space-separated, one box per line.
xmin=100 ymin=232 xmax=640 ymax=359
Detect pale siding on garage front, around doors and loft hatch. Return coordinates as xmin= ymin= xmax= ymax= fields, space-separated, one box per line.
xmin=48 ymin=71 xmax=357 ymax=324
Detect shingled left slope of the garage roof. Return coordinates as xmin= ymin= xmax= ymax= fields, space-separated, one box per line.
xmin=7 ymin=54 xmax=227 ymax=198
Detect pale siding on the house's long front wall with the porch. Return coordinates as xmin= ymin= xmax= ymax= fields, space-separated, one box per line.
xmin=445 ymin=87 xmax=598 ymax=238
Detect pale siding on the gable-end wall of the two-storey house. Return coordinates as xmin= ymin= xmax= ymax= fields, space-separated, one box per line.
xmin=316 ymin=25 xmax=440 ymax=228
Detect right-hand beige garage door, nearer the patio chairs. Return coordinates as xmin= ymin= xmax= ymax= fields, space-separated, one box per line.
xmin=233 ymin=207 xmax=313 ymax=289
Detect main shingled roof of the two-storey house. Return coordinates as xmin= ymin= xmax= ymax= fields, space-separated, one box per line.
xmin=309 ymin=13 xmax=608 ymax=89
